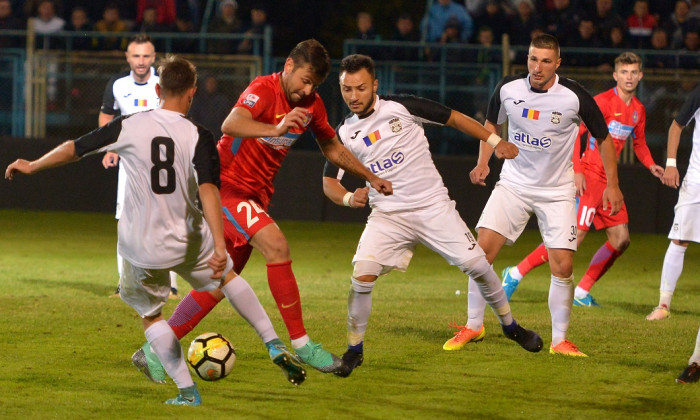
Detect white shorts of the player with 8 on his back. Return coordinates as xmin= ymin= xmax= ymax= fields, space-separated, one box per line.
xmin=119 ymin=246 xmax=233 ymax=318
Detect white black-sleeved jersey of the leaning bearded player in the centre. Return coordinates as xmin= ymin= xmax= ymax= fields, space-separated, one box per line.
xmin=324 ymin=95 xmax=451 ymax=211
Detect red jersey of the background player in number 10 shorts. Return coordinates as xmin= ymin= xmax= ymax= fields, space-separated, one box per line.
xmin=574 ymin=87 xmax=654 ymax=181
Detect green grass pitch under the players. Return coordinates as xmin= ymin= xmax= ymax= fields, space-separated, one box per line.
xmin=0 ymin=211 xmax=700 ymax=420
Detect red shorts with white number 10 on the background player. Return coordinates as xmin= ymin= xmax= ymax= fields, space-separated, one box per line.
xmin=576 ymin=176 xmax=629 ymax=231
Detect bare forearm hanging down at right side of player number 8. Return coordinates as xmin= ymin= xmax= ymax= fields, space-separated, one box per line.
xmin=199 ymin=183 xmax=226 ymax=279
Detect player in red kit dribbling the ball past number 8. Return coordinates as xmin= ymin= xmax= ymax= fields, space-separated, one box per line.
xmin=132 ymin=39 xmax=392 ymax=379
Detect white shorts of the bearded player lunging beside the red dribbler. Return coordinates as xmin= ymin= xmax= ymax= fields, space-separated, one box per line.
xmin=352 ymin=200 xmax=484 ymax=271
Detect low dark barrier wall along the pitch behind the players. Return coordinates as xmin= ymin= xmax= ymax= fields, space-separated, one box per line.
xmin=0 ymin=137 xmax=688 ymax=234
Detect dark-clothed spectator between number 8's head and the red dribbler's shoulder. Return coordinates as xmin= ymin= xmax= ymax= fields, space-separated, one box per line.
xmin=189 ymin=75 xmax=233 ymax=139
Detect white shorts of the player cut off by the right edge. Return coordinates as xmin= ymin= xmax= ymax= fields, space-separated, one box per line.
xmin=668 ymin=178 xmax=700 ymax=243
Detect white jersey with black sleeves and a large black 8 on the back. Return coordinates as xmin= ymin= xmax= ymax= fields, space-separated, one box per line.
xmin=75 ymin=109 xmax=220 ymax=268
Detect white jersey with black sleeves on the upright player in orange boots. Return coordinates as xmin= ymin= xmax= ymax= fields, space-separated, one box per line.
xmin=486 ymin=73 xmax=608 ymax=190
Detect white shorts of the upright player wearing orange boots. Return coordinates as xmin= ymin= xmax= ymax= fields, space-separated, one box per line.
xmin=476 ymin=181 xmax=576 ymax=251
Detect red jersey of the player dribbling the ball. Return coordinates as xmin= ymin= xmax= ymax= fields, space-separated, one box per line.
xmin=218 ymin=73 xmax=335 ymax=209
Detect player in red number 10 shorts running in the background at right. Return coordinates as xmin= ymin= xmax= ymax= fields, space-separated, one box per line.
xmin=502 ymin=52 xmax=664 ymax=307
